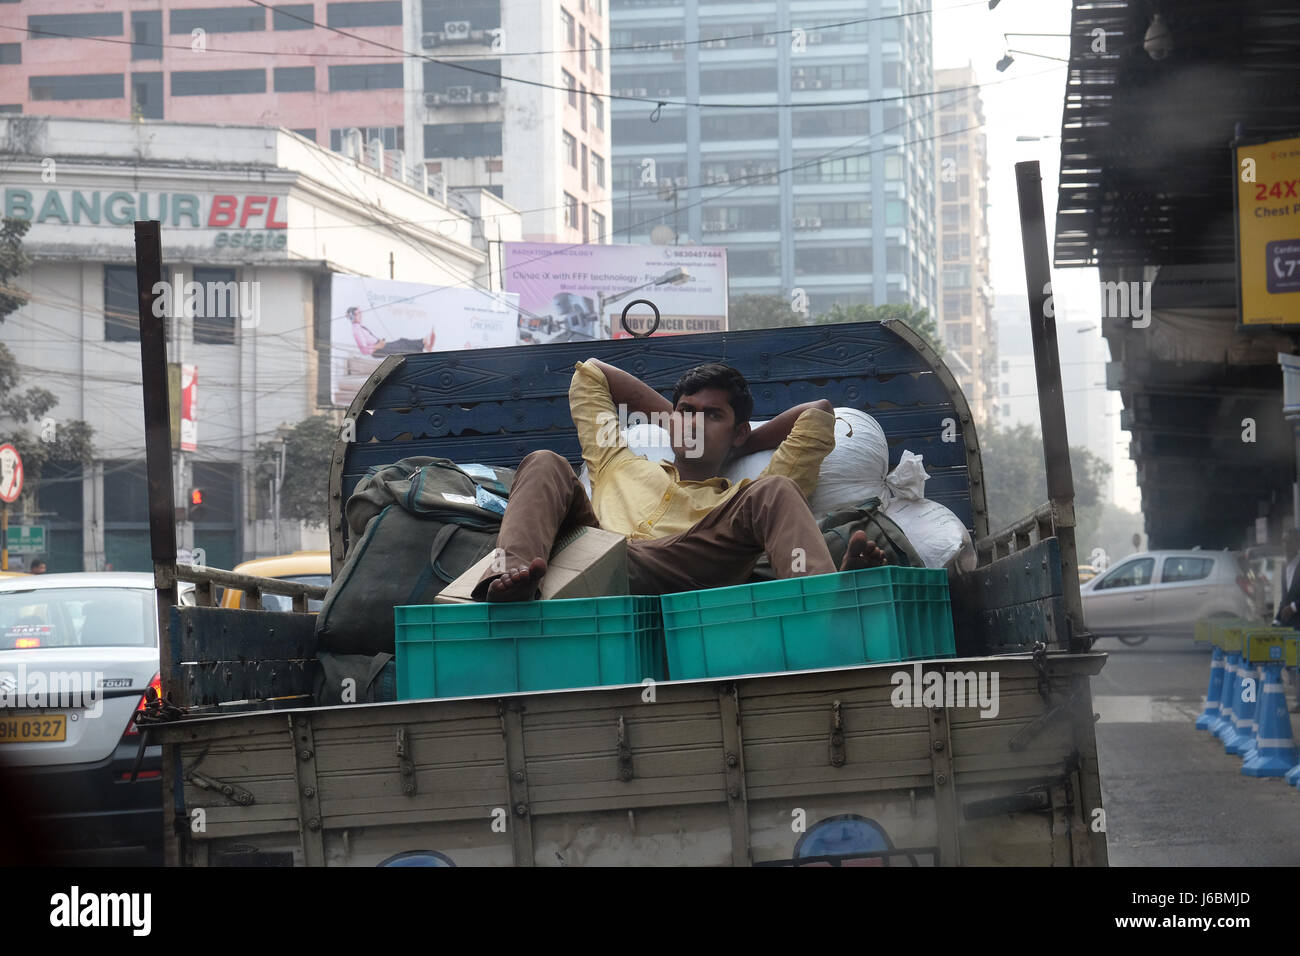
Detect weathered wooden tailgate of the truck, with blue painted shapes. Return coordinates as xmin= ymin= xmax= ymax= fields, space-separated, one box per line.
xmin=153 ymin=653 xmax=1106 ymax=866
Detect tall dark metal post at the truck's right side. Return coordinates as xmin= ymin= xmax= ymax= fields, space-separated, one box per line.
xmin=1015 ymin=161 xmax=1091 ymax=650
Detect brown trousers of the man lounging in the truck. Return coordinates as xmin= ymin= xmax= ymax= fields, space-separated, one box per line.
xmin=475 ymin=451 xmax=837 ymax=601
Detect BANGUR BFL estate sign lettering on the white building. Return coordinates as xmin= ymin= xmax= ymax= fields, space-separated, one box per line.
xmin=4 ymin=187 xmax=289 ymax=250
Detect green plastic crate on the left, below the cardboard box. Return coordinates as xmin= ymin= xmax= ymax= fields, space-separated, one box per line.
xmin=394 ymin=596 xmax=667 ymax=700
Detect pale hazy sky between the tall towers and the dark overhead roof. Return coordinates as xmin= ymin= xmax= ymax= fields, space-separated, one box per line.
xmin=932 ymin=0 xmax=1140 ymax=511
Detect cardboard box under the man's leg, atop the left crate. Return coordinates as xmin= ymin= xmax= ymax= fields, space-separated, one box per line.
xmin=434 ymin=528 xmax=628 ymax=604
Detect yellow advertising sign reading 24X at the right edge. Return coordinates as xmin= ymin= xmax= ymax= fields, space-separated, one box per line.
xmin=1234 ymin=139 xmax=1300 ymax=325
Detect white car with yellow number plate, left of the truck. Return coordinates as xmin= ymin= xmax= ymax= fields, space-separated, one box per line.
xmin=0 ymin=572 xmax=194 ymax=853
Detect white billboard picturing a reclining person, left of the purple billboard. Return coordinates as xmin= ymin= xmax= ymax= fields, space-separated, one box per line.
xmin=330 ymin=273 xmax=519 ymax=405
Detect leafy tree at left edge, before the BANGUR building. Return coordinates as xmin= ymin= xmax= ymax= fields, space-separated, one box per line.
xmin=0 ymin=217 xmax=95 ymax=501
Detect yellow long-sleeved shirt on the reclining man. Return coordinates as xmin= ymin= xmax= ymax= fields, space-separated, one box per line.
xmin=569 ymin=362 xmax=835 ymax=538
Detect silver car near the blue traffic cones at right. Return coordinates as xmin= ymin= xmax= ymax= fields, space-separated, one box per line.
xmin=1080 ymin=550 xmax=1258 ymax=644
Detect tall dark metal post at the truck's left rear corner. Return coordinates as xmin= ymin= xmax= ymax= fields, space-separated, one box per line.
xmin=135 ymin=220 xmax=181 ymax=865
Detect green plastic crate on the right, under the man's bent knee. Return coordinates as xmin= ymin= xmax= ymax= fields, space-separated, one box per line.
xmin=660 ymin=566 xmax=956 ymax=680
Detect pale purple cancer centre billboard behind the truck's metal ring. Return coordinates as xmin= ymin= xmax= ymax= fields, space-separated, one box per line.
xmin=504 ymin=242 xmax=727 ymax=343
